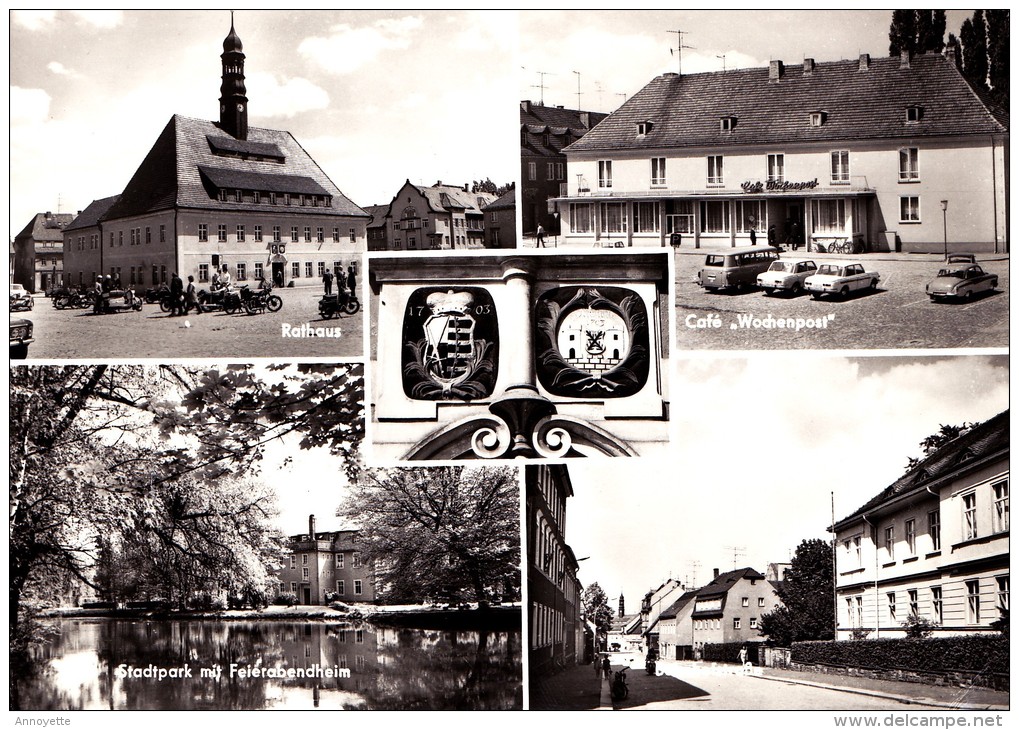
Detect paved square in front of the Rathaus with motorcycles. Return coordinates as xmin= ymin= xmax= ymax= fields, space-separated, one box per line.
xmin=11 ymin=288 xmax=364 ymax=361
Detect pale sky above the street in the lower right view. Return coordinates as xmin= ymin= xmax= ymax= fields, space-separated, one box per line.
xmin=567 ymin=352 xmax=1009 ymax=613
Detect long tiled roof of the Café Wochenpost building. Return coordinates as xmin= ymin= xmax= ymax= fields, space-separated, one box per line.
xmin=569 ymin=54 xmax=1008 ymax=152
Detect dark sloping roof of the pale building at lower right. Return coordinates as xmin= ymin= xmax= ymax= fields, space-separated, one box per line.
xmin=835 ymin=411 xmax=1009 ymax=528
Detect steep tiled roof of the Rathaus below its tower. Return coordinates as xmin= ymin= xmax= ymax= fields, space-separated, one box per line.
xmin=103 ymin=115 xmax=368 ymax=220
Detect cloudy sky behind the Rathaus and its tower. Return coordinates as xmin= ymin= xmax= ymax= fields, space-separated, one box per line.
xmin=9 ymin=10 xmax=520 ymax=238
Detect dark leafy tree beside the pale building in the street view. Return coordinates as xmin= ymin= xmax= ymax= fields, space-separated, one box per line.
xmin=760 ymin=538 xmax=835 ymax=646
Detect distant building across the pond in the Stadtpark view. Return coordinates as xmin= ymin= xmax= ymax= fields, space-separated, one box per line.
xmin=276 ymin=515 xmax=376 ymax=606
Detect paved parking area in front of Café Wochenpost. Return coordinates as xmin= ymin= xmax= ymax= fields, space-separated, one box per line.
xmin=676 ymin=250 xmax=1009 ymax=350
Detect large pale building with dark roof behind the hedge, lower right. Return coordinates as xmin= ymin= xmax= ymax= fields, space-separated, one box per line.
xmin=834 ymin=411 xmax=1009 ymax=639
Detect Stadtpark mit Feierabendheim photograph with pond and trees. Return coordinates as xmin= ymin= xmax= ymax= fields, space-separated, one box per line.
xmin=9 ymin=365 xmax=523 ymax=711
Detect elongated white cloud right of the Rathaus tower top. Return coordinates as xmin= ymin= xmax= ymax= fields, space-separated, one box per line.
xmin=298 ymin=15 xmax=423 ymax=74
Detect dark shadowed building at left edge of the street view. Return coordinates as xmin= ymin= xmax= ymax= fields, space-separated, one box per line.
xmin=524 ymin=465 xmax=585 ymax=678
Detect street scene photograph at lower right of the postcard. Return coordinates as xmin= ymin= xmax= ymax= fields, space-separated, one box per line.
xmin=526 ymin=355 xmax=1009 ymax=711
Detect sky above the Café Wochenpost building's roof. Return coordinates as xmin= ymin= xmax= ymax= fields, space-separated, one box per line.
xmin=519 ymin=9 xmax=973 ymax=112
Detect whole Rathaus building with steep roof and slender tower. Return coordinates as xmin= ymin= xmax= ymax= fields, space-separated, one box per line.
xmin=63 ymin=19 xmax=369 ymax=288
